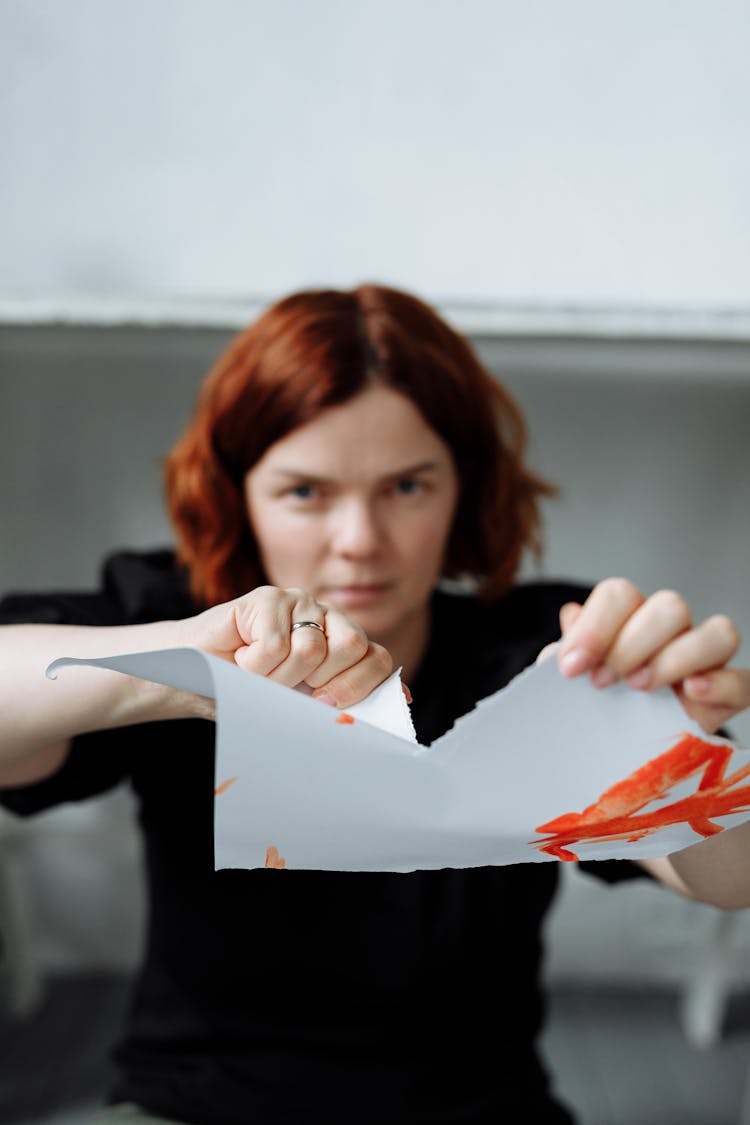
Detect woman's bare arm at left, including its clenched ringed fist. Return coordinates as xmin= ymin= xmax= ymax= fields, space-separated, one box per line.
xmin=0 ymin=586 xmax=392 ymax=786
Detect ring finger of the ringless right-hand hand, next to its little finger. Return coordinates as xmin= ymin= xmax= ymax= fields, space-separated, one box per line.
xmin=627 ymin=614 xmax=740 ymax=690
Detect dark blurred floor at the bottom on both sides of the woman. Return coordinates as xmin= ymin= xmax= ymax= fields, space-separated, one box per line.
xmin=0 ymin=975 xmax=750 ymax=1125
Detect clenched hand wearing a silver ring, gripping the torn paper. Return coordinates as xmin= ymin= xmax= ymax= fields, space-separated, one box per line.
xmin=184 ymin=586 xmax=392 ymax=708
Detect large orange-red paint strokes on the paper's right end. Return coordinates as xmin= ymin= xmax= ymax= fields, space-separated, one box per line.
xmin=532 ymin=735 xmax=750 ymax=862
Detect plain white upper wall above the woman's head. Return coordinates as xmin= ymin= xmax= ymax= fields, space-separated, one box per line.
xmin=0 ymin=0 xmax=750 ymax=307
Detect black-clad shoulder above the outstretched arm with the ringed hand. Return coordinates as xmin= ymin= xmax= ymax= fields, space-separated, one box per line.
xmin=0 ymin=550 xmax=196 ymax=626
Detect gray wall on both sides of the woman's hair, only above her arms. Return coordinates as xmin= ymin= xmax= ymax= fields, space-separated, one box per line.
xmin=0 ymin=327 xmax=750 ymax=740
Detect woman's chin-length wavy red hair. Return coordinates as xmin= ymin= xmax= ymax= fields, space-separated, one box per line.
xmin=166 ymin=285 xmax=554 ymax=605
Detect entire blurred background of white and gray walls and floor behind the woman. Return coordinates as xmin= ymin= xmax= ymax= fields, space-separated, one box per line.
xmin=0 ymin=0 xmax=750 ymax=1125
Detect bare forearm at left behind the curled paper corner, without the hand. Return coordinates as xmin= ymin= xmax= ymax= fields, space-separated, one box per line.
xmin=0 ymin=621 xmax=208 ymax=784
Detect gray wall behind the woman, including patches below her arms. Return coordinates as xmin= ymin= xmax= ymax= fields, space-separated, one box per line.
xmin=0 ymin=326 xmax=750 ymax=995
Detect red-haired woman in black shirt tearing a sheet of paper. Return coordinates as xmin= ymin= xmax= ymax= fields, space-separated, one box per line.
xmin=0 ymin=286 xmax=750 ymax=1125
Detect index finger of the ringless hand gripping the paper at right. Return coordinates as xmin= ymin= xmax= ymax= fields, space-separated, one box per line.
xmin=558 ymin=578 xmax=644 ymax=676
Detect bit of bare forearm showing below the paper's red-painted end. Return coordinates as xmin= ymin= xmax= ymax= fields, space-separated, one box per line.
xmin=641 ymin=821 xmax=750 ymax=910
